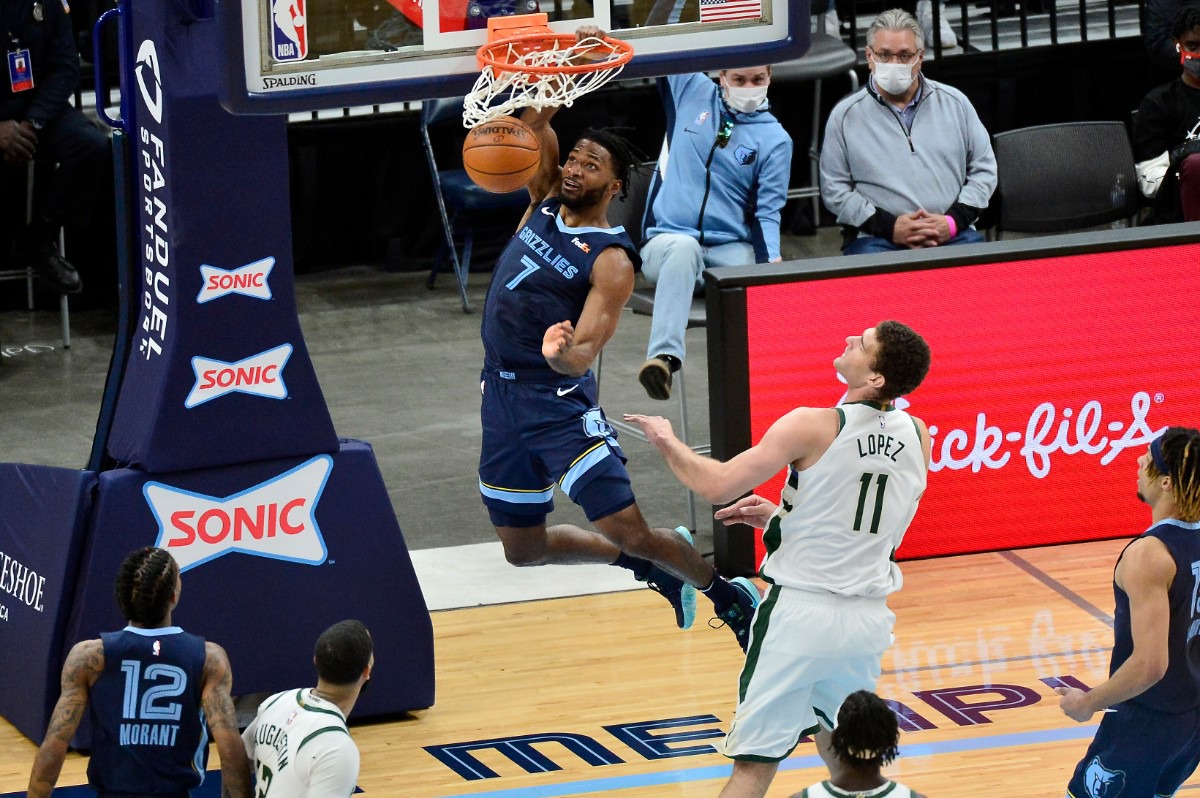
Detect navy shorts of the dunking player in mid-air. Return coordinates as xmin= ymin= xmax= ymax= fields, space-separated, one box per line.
xmin=479 ymin=371 xmax=634 ymax=527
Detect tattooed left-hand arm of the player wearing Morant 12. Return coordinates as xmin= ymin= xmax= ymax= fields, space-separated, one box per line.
xmin=29 ymin=640 xmax=104 ymax=798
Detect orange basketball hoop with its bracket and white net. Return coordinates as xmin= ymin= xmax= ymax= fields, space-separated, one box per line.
xmin=462 ymin=13 xmax=634 ymax=127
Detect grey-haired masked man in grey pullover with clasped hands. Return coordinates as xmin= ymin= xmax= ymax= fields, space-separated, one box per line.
xmin=821 ymin=8 xmax=996 ymax=254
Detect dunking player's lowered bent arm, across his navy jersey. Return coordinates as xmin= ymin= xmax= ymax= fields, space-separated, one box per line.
xmin=541 ymin=247 xmax=634 ymax=377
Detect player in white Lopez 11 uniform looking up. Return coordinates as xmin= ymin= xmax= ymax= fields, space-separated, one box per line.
xmin=625 ymin=322 xmax=930 ymax=798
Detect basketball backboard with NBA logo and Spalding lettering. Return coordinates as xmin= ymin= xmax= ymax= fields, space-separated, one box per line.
xmin=217 ymin=0 xmax=810 ymax=114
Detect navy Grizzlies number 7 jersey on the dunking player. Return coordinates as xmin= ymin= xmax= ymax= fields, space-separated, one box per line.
xmin=482 ymin=197 xmax=642 ymax=371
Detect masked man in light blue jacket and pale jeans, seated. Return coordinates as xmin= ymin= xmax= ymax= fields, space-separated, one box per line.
xmin=637 ymin=66 xmax=792 ymax=400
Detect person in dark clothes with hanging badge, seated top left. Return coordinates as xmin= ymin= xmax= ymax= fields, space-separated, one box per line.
xmin=0 ymin=0 xmax=112 ymax=294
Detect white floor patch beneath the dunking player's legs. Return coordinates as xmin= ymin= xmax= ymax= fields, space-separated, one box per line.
xmin=409 ymin=541 xmax=643 ymax=611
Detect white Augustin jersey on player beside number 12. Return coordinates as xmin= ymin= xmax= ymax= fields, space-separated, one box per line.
xmin=241 ymin=689 xmax=359 ymax=798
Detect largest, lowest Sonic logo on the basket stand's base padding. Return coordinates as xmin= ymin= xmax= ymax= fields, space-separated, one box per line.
xmin=142 ymin=455 xmax=334 ymax=571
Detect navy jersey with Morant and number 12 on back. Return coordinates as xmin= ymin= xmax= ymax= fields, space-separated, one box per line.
xmin=88 ymin=626 xmax=209 ymax=796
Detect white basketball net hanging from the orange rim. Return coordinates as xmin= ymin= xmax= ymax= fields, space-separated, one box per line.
xmin=462 ymin=38 xmax=625 ymax=128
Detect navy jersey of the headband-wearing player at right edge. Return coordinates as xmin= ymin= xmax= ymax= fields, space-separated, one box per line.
xmin=1109 ymin=518 xmax=1200 ymax=714
